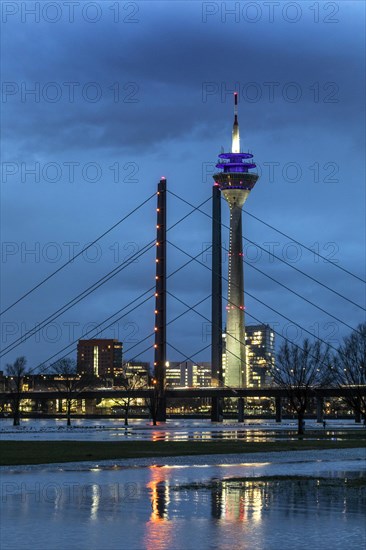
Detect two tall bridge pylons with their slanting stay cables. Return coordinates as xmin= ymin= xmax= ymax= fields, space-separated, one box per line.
xmin=0 ymin=179 xmax=366 ymax=419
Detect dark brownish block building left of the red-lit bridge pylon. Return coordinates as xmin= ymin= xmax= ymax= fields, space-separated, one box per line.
xmin=77 ymin=339 xmax=122 ymax=376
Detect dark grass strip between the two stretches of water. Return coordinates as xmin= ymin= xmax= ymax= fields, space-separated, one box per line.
xmin=0 ymin=438 xmax=366 ymax=466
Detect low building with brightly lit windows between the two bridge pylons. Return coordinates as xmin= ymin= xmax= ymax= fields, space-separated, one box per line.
xmin=166 ymin=361 xmax=212 ymax=388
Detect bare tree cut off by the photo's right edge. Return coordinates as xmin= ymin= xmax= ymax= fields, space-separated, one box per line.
xmin=333 ymin=323 xmax=366 ymax=419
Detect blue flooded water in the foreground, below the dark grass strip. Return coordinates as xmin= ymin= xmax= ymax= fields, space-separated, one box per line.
xmin=1 ymin=464 xmax=366 ymax=550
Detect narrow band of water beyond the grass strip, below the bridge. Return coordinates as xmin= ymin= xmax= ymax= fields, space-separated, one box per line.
xmin=0 ymin=418 xmax=366 ymax=441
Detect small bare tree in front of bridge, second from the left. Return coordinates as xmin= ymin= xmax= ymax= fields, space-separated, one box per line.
xmin=52 ymin=358 xmax=93 ymax=426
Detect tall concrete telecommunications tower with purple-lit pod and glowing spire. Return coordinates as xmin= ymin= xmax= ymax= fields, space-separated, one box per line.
xmin=213 ymin=92 xmax=259 ymax=388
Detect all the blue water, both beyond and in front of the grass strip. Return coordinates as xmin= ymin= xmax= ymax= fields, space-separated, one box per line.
xmin=0 ymin=419 xmax=366 ymax=550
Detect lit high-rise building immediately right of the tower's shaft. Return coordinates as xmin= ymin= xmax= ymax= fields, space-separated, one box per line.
xmin=245 ymin=325 xmax=275 ymax=388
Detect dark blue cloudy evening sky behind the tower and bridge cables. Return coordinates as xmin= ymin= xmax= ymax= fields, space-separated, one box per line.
xmin=1 ymin=1 xmax=365 ymax=376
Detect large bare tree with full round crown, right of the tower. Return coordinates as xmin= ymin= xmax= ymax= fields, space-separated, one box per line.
xmin=270 ymin=338 xmax=330 ymax=435
